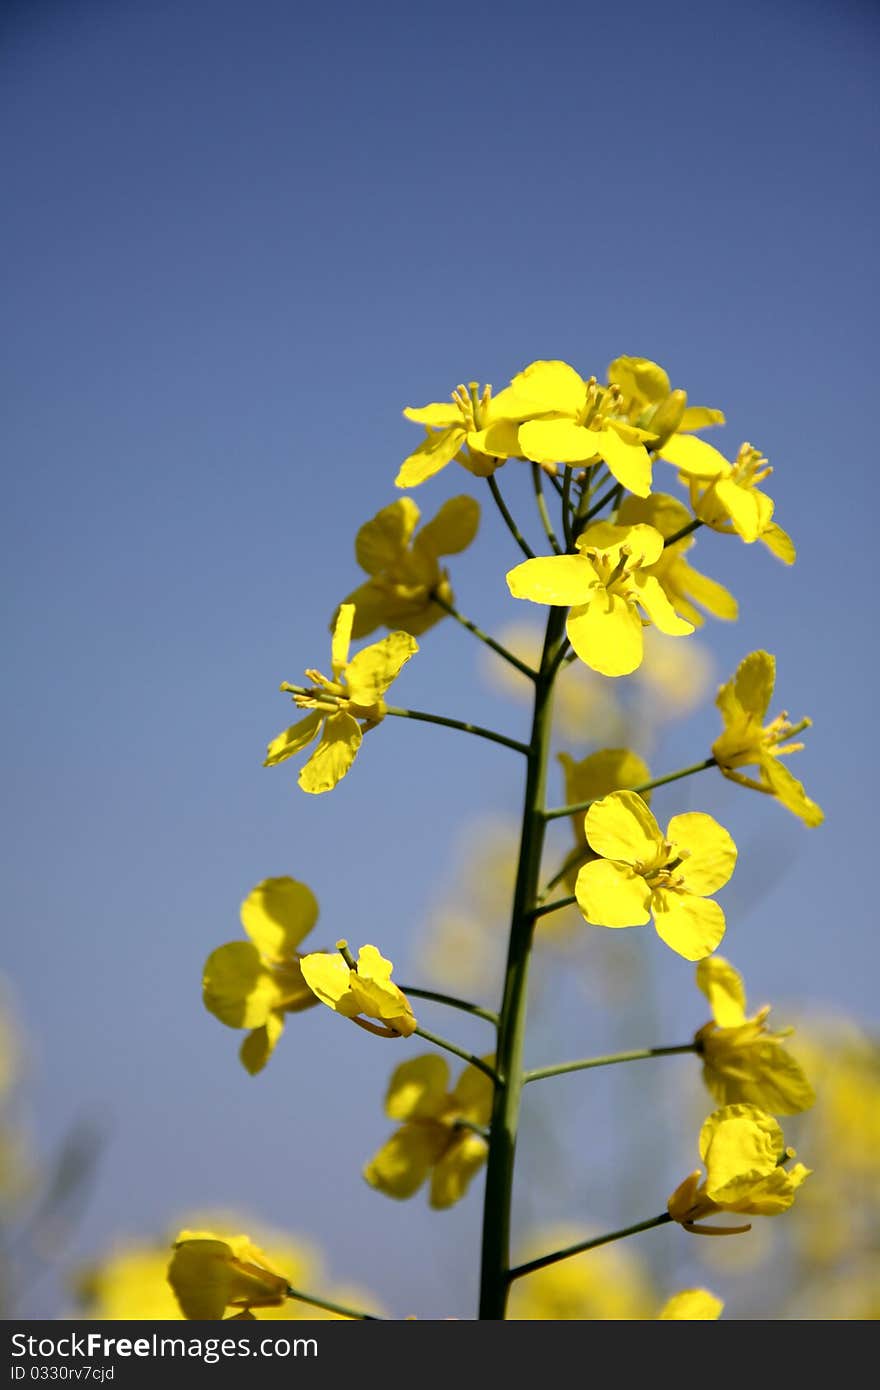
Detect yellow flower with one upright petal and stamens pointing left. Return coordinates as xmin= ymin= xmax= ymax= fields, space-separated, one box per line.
xmin=263 ymin=603 xmax=418 ymax=794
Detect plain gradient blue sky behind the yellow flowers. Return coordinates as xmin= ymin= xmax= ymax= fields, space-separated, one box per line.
xmin=0 ymin=0 xmax=879 ymax=1316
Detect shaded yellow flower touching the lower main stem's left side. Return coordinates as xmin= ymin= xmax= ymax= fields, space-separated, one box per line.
xmin=364 ymin=1055 xmax=494 ymax=1209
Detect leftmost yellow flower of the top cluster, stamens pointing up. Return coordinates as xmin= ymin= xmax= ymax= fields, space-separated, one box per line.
xmin=395 ymin=381 xmax=531 ymax=488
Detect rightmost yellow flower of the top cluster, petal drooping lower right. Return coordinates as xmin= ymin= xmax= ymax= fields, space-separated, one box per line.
xmin=660 ymin=435 xmax=797 ymax=564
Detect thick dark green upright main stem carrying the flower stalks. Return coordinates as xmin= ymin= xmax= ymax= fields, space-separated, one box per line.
xmin=480 ymin=607 xmax=567 ymax=1321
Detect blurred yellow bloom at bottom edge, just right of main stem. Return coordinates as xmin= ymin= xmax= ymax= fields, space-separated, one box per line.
xmin=507 ymin=1227 xmax=656 ymax=1322
